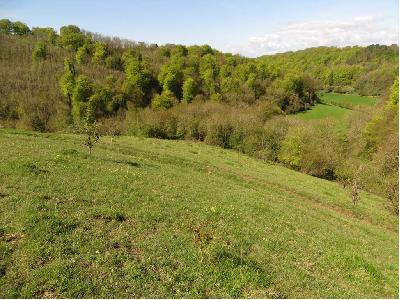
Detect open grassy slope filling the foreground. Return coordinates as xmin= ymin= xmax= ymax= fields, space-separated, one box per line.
xmin=0 ymin=130 xmax=398 ymax=298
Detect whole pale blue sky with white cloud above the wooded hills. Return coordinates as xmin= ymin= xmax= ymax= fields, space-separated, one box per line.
xmin=0 ymin=0 xmax=399 ymax=57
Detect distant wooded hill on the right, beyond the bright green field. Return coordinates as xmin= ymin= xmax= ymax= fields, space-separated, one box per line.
xmin=257 ymin=45 xmax=398 ymax=95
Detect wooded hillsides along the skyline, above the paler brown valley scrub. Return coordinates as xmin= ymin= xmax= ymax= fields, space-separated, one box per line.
xmin=0 ymin=19 xmax=398 ymax=131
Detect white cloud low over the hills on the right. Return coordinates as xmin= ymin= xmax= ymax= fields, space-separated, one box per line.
xmin=228 ymin=16 xmax=398 ymax=56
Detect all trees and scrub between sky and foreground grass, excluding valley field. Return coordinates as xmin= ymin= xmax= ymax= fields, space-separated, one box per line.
xmin=0 ymin=20 xmax=398 ymax=213
